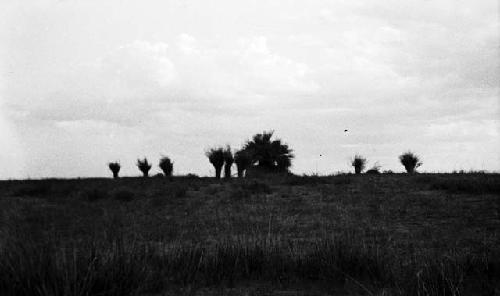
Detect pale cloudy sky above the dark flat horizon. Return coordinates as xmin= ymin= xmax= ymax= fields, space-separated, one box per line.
xmin=0 ymin=0 xmax=500 ymax=179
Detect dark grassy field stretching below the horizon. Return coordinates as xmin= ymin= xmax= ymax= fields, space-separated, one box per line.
xmin=0 ymin=174 xmax=500 ymax=295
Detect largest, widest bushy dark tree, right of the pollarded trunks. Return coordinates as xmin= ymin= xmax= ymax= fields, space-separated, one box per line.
xmin=243 ymin=131 xmax=294 ymax=172
